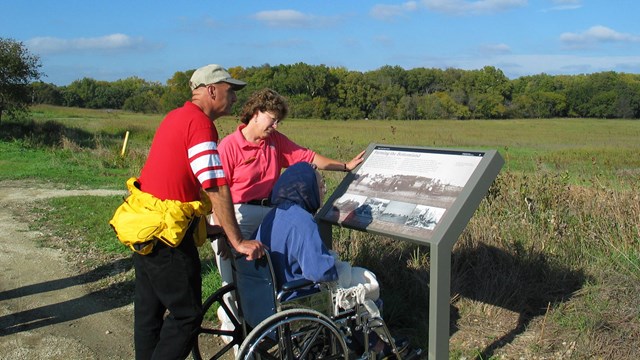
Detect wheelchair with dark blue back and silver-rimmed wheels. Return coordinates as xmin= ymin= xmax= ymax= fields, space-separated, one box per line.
xmin=192 ymin=250 xmax=421 ymax=360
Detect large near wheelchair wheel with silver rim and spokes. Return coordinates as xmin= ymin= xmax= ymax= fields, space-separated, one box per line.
xmin=236 ymin=309 xmax=349 ymax=360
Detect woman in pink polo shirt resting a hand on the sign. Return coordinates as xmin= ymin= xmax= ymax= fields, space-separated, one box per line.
xmin=212 ymin=89 xmax=364 ymax=340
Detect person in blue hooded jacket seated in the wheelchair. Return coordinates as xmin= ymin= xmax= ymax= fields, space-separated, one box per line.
xmin=255 ymin=162 xmax=408 ymax=358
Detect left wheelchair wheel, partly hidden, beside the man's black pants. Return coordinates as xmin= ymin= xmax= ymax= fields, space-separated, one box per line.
xmin=191 ymin=284 xmax=244 ymax=360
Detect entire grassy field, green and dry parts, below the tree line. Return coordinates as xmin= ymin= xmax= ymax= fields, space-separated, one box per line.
xmin=0 ymin=106 xmax=640 ymax=359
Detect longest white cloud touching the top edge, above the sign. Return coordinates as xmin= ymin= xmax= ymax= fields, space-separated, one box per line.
xmin=421 ymin=0 xmax=528 ymax=15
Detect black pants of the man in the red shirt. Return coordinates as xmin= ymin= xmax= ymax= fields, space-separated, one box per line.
xmin=133 ymin=236 xmax=202 ymax=360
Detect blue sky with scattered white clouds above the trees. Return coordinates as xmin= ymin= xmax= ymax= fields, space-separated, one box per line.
xmin=0 ymin=0 xmax=640 ymax=85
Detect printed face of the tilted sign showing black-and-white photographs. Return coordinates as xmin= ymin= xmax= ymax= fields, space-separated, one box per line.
xmin=320 ymin=146 xmax=483 ymax=240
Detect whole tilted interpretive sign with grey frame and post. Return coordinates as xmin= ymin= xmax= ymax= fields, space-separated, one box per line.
xmin=316 ymin=144 xmax=504 ymax=360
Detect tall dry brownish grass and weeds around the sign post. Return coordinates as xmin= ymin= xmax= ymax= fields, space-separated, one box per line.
xmin=332 ymin=172 xmax=640 ymax=359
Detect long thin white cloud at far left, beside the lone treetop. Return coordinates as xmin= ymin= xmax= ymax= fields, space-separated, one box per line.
xmin=25 ymin=34 xmax=144 ymax=54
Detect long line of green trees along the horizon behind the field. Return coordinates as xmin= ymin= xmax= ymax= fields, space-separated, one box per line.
xmin=5 ymin=38 xmax=640 ymax=120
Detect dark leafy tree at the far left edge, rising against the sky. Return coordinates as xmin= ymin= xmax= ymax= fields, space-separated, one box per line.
xmin=0 ymin=38 xmax=42 ymax=120
